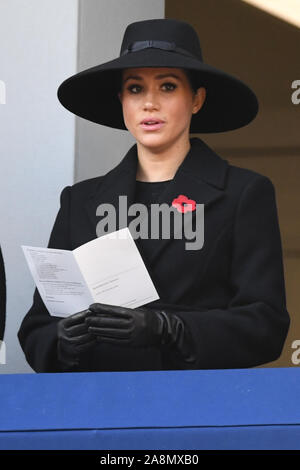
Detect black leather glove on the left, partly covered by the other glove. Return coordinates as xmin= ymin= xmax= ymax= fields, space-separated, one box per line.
xmin=57 ymin=310 xmax=97 ymax=370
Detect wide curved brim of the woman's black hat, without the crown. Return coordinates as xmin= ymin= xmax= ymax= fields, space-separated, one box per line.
xmin=57 ymin=48 xmax=258 ymax=133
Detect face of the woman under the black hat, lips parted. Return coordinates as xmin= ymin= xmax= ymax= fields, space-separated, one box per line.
xmin=119 ymin=67 xmax=205 ymax=151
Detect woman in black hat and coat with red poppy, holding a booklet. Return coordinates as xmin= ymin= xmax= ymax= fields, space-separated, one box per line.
xmin=19 ymin=19 xmax=289 ymax=372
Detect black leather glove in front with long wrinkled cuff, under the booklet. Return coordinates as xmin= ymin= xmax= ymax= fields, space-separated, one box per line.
xmin=85 ymin=303 xmax=195 ymax=362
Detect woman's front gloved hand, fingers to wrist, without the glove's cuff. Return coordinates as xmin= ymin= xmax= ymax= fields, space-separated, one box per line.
xmin=85 ymin=303 xmax=165 ymax=347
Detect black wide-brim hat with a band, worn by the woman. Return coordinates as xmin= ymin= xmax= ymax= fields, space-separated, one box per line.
xmin=57 ymin=19 xmax=258 ymax=133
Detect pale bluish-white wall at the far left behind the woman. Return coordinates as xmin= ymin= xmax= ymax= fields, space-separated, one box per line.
xmin=0 ymin=0 xmax=78 ymax=373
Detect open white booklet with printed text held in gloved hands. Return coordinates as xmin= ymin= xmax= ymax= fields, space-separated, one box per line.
xmin=22 ymin=227 xmax=159 ymax=317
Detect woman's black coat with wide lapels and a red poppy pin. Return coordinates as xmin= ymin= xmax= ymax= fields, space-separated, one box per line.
xmin=18 ymin=138 xmax=289 ymax=372
